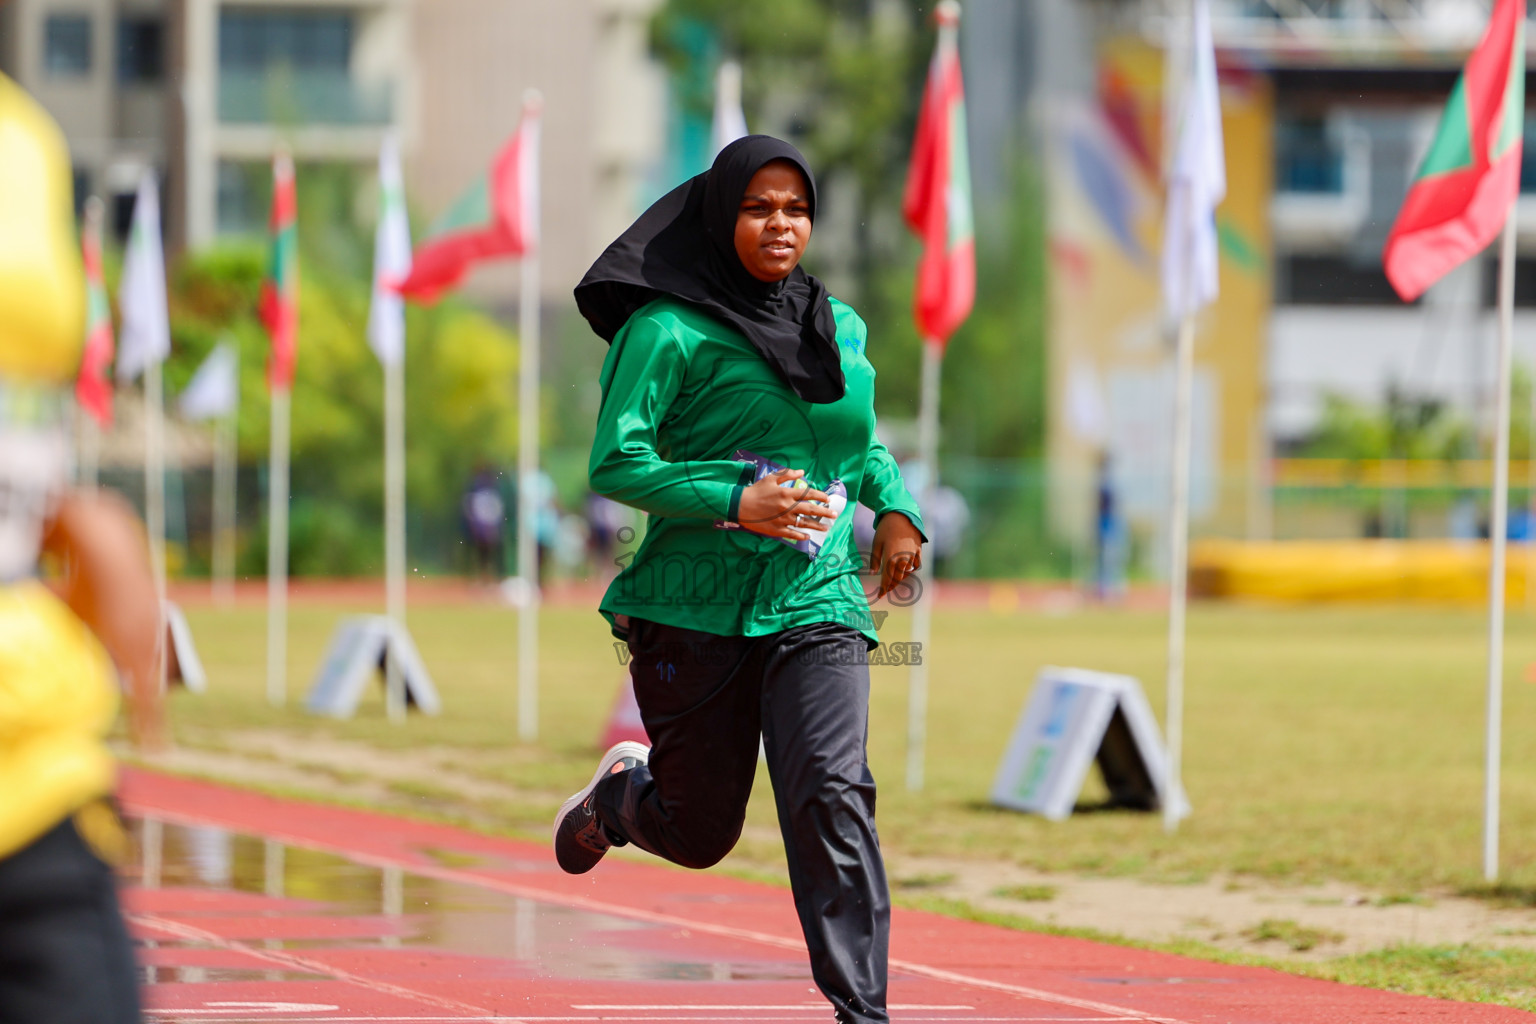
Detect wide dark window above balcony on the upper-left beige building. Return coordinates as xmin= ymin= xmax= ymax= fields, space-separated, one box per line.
xmin=218 ymin=8 xmax=352 ymax=74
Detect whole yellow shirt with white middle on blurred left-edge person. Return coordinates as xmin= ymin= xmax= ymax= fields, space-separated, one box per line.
xmin=0 ymin=75 xmax=118 ymax=858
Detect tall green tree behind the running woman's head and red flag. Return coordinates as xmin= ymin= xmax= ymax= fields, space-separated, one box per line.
xmin=651 ymin=0 xmax=1048 ymax=576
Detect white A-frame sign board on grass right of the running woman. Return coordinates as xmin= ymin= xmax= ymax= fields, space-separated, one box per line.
xmin=992 ymin=668 xmax=1189 ymax=821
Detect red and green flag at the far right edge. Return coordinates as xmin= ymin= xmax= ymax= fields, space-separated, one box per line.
xmin=1382 ymin=0 xmax=1525 ymax=301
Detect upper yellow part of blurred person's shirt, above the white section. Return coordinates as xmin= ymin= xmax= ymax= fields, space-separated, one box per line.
xmin=0 ymin=75 xmax=86 ymax=385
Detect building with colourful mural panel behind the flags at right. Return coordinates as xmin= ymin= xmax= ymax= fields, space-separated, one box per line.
xmin=1031 ymin=0 xmax=1536 ymax=547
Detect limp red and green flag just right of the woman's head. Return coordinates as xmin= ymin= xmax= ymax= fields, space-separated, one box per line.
xmin=902 ymin=0 xmax=975 ymax=345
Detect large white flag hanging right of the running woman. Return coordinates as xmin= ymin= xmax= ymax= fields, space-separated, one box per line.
xmin=1163 ymin=0 xmax=1227 ymax=319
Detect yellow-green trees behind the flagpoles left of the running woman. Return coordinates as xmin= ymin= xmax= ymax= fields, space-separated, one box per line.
xmin=166 ymin=246 xmax=518 ymax=576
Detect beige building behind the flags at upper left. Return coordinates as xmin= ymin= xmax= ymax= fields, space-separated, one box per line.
xmin=0 ymin=0 xmax=667 ymax=301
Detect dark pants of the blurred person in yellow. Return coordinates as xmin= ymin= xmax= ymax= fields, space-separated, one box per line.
xmin=0 ymin=820 xmax=140 ymax=1024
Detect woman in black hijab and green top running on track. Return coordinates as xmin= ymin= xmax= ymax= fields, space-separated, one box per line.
xmin=554 ymin=135 xmax=925 ymax=1024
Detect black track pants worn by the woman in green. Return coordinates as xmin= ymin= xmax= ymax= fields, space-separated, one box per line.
xmin=596 ymin=619 xmax=891 ymax=1022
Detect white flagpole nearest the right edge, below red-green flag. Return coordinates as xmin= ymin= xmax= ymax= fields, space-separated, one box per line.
xmin=1482 ymin=207 xmax=1514 ymax=881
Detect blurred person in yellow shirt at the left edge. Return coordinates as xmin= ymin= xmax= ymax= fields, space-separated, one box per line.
xmin=0 ymin=57 xmax=164 ymax=1024
